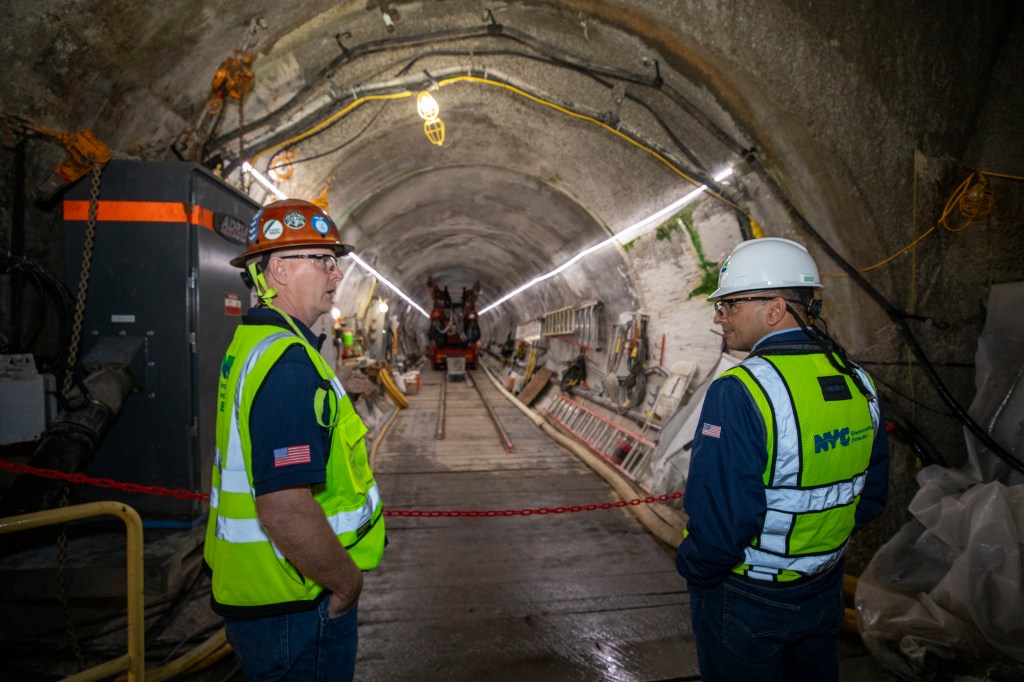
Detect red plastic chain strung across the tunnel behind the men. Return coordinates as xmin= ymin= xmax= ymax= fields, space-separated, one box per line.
xmin=0 ymin=461 xmax=683 ymax=518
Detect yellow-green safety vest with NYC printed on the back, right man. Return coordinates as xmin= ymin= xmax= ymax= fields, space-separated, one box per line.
xmin=722 ymin=353 xmax=880 ymax=583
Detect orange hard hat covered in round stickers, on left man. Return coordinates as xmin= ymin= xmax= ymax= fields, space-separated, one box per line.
xmin=231 ymin=199 xmax=355 ymax=267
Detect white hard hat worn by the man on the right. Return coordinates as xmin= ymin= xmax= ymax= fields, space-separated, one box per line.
xmin=708 ymin=237 xmax=824 ymax=301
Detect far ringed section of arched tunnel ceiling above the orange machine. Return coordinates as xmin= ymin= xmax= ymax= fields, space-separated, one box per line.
xmin=350 ymin=165 xmax=599 ymax=301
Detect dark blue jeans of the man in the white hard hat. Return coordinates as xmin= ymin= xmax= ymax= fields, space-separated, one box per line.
xmin=690 ymin=571 xmax=844 ymax=682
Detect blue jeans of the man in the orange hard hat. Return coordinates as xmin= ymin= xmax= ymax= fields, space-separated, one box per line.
xmin=224 ymin=599 xmax=359 ymax=682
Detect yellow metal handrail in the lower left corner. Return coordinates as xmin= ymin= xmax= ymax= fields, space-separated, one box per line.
xmin=0 ymin=502 xmax=145 ymax=682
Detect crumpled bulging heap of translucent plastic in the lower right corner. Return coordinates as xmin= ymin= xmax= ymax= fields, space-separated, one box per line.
xmin=856 ymin=466 xmax=1024 ymax=679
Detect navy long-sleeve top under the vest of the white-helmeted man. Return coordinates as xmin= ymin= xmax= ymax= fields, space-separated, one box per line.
xmin=676 ymin=329 xmax=889 ymax=588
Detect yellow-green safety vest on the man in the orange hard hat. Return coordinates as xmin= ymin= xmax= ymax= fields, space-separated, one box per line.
xmin=203 ymin=325 xmax=385 ymax=610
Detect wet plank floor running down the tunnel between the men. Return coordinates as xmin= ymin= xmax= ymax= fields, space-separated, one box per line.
xmin=356 ymin=370 xmax=698 ymax=682
